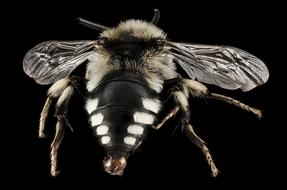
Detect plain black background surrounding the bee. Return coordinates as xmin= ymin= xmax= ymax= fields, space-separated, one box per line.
xmin=2 ymin=1 xmax=286 ymax=189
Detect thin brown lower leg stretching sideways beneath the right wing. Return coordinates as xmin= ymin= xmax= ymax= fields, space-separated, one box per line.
xmin=207 ymin=93 xmax=262 ymax=119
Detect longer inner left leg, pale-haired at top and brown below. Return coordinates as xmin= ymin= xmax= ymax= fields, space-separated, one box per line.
xmin=50 ymin=86 xmax=75 ymax=176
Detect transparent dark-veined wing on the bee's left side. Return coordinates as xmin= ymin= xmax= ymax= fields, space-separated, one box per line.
xmin=23 ymin=41 xmax=97 ymax=84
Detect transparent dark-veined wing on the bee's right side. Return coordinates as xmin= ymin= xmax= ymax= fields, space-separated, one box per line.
xmin=168 ymin=42 xmax=269 ymax=91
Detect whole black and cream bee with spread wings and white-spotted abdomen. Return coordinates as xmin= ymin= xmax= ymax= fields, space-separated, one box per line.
xmin=23 ymin=9 xmax=269 ymax=177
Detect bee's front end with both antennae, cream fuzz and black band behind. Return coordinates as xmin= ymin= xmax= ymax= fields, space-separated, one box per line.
xmin=79 ymin=9 xmax=166 ymax=57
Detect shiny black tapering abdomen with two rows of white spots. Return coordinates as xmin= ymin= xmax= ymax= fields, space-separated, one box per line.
xmin=86 ymin=71 xmax=160 ymax=154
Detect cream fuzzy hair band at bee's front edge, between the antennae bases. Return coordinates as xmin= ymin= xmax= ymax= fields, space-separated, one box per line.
xmin=100 ymin=19 xmax=166 ymax=40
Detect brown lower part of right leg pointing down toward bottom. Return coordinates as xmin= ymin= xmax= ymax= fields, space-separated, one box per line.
xmin=184 ymin=121 xmax=219 ymax=177
